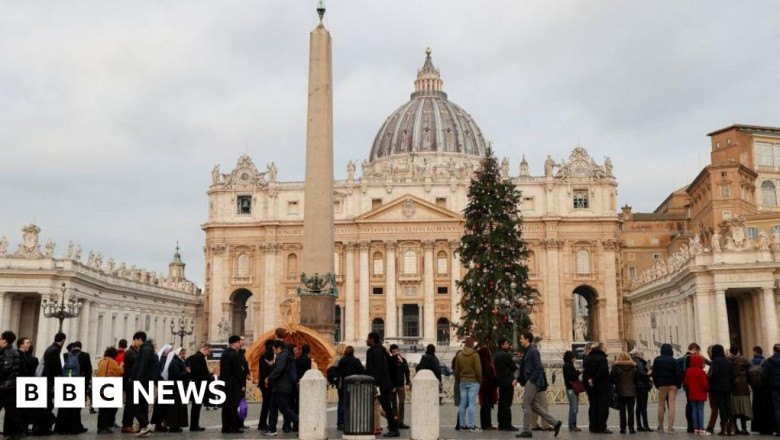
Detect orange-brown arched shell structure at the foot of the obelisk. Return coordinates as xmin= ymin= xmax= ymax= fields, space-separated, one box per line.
xmin=246 ymin=323 xmax=336 ymax=379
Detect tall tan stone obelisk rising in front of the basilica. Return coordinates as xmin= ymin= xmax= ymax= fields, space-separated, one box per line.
xmin=299 ymin=1 xmax=337 ymax=342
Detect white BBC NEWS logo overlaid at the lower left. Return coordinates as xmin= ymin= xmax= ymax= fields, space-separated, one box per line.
xmin=16 ymin=377 xmax=227 ymax=409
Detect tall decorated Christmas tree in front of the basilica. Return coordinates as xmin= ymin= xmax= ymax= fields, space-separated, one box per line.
xmin=455 ymin=148 xmax=536 ymax=345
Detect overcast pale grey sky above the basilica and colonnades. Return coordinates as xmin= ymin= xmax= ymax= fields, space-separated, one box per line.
xmin=0 ymin=0 xmax=780 ymax=285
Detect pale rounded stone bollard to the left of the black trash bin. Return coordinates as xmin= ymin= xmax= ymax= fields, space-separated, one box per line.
xmin=298 ymin=369 xmax=328 ymax=440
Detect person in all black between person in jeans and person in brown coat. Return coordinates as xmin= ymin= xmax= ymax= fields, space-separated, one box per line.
xmin=582 ymin=342 xmax=612 ymax=434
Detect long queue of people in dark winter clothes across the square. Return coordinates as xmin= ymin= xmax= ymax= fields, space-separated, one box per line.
xmin=0 ymin=328 xmax=780 ymax=439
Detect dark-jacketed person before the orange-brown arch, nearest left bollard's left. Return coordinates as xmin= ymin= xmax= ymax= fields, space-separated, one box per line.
xmin=263 ymin=341 xmax=298 ymax=436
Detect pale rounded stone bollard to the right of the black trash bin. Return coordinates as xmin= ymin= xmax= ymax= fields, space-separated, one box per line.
xmin=412 ymin=370 xmax=439 ymax=440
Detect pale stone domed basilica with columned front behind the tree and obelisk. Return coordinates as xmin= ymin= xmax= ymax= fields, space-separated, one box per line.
xmin=202 ymin=51 xmax=623 ymax=351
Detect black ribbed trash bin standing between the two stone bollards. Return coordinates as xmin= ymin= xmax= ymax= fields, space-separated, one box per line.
xmin=344 ymin=374 xmax=374 ymax=435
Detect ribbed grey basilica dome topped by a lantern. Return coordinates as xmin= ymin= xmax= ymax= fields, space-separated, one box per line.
xmin=369 ymin=48 xmax=486 ymax=162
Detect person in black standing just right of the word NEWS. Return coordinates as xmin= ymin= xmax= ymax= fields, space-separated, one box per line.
xmin=219 ymin=335 xmax=246 ymax=434
